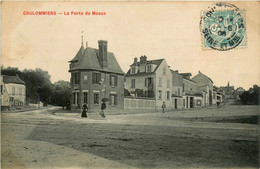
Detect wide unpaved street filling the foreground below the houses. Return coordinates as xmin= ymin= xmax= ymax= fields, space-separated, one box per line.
xmin=1 ymin=105 xmax=259 ymax=169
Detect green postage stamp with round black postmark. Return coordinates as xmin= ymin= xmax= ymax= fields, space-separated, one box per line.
xmin=200 ymin=2 xmax=247 ymax=51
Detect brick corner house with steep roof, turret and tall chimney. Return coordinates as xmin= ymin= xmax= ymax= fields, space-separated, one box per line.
xmin=69 ymin=40 xmax=124 ymax=109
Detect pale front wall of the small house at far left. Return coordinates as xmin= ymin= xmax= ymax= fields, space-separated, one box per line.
xmin=5 ymin=83 xmax=26 ymax=107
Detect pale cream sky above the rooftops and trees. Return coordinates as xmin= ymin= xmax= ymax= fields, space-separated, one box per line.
xmin=1 ymin=2 xmax=260 ymax=89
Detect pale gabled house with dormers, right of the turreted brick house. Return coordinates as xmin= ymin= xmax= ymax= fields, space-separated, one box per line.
xmin=125 ymin=56 xmax=172 ymax=109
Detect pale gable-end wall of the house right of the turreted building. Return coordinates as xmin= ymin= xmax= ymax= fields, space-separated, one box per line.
xmin=155 ymin=59 xmax=173 ymax=110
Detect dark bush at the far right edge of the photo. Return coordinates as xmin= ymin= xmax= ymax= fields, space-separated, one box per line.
xmin=240 ymin=85 xmax=260 ymax=105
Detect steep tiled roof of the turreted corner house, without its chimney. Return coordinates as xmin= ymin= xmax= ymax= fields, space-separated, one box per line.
xmin=69 ymin=47 xmax=124 ymax=74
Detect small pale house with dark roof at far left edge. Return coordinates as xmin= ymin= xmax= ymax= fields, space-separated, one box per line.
xmin=1 ymin=75 xmax=26 ymax=108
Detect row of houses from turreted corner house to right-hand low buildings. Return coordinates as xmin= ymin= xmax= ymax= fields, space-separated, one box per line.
xmin=69 ymin=40 xmax=230 ymax=109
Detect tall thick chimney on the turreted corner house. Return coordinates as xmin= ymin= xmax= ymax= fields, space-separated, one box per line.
xmin=98 ymin=40 xmax=107 ymax=68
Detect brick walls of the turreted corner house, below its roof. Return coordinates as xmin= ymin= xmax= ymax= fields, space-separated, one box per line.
xmin=71 ymin=70 xmax=124 ymax=109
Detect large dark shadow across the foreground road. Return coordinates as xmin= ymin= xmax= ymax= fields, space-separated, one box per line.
xmin=27 ymin=122 xmax=259 ymax=168
